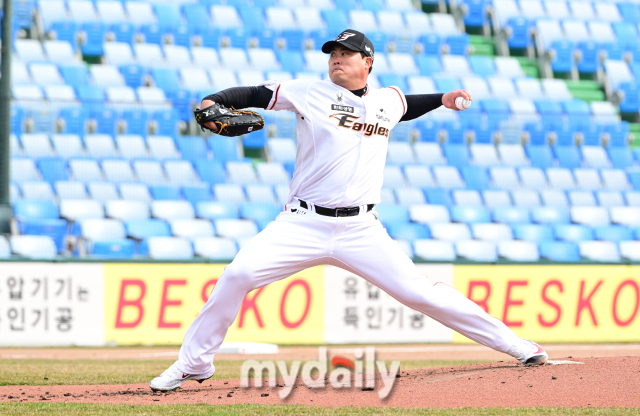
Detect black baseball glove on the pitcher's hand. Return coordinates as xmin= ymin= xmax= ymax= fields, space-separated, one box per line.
xmin=193 ymin=104 xmax=264 ymax=137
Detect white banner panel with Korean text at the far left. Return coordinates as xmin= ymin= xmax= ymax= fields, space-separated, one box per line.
xmin=0 ymin=262 xmax=104 ymax=346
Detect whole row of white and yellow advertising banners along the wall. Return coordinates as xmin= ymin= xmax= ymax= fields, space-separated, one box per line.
xmin=0 ymin=262 xmax=640 ymax=346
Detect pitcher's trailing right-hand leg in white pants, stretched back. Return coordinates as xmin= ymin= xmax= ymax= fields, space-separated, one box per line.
xmin=333 ymin=221 xmax=517 ymax=352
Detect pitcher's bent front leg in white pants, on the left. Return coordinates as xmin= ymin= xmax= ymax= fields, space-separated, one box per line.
xmin=178 ymin=214 xmax=326 ymax=374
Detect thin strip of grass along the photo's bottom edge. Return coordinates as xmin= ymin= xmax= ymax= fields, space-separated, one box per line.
xmin=0 ymin=403 xmax=640 ymax=416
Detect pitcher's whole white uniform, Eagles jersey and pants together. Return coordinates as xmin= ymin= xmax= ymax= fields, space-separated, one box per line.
xmin=178 ymin=80 xmax=516 ymax=374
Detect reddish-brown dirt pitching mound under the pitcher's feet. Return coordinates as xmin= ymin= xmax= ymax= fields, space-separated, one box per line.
xmin=0 ymin=357 xmax=640 ymax=408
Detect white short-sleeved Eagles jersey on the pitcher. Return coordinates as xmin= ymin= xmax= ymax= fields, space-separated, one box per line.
xmin=261 ymin=79 xmax=407 ymax=208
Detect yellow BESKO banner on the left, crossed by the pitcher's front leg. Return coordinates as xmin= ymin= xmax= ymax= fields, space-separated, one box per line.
xmin=104 ymin=264 xmax=324 ymax=345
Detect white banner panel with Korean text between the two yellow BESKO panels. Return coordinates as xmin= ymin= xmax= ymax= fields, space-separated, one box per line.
xmin=325 ymin=264 xmax=453 ymax=344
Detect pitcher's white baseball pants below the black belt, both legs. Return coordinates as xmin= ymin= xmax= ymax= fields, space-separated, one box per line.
xmin=178 ymin=201 xmax=516 ymax=374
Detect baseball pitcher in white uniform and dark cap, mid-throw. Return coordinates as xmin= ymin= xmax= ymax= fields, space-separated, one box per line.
xmin=149 ymin=30 xmax=547 ymax=391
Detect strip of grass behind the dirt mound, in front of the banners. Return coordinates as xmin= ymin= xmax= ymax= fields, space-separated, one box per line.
xmin=0 ymin=360 xmax=490 ymax=386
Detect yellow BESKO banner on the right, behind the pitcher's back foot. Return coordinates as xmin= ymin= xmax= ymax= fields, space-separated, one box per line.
xmin=454 ymin=265 xmax=640 ymax=342
